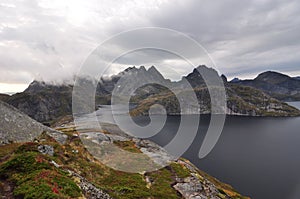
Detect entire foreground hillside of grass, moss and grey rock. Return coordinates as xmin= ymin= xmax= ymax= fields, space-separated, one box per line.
xmin=0 ymin=103 xmax=246 ymax=199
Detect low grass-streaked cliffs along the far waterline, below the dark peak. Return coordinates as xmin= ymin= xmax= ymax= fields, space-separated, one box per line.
xmin=131 ymin=85 xmax=300 ymax=116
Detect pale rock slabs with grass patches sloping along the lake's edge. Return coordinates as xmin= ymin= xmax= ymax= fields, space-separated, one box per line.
xmin=55 ymin=120 xmax=247 ymax=199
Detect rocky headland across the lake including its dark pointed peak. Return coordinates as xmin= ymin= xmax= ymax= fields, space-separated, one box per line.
xmin=131 ymin=66 xmax=300 ymax=116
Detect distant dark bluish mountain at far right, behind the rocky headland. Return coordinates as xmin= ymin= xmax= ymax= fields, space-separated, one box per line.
xmin=232 ymin=71 xmax=300 ymax=101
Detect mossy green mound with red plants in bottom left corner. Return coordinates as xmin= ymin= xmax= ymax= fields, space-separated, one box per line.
xmin=0 ymin=151 xmax=81 ymax=199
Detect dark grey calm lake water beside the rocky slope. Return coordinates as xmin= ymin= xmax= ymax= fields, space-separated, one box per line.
xmin=132 ymin=102 xmax=300 ymax=199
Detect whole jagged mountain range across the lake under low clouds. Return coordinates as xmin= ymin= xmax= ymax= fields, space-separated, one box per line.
xmin=0 ymin=65 xmax=300 ymax=125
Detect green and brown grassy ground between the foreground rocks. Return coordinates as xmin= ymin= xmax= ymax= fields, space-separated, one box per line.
xmin=0 ymin=126 xmax=248 ymax=199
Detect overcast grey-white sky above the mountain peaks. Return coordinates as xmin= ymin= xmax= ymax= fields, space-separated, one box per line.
xmin=0 ymin=0 xmax=300 ymax=92
